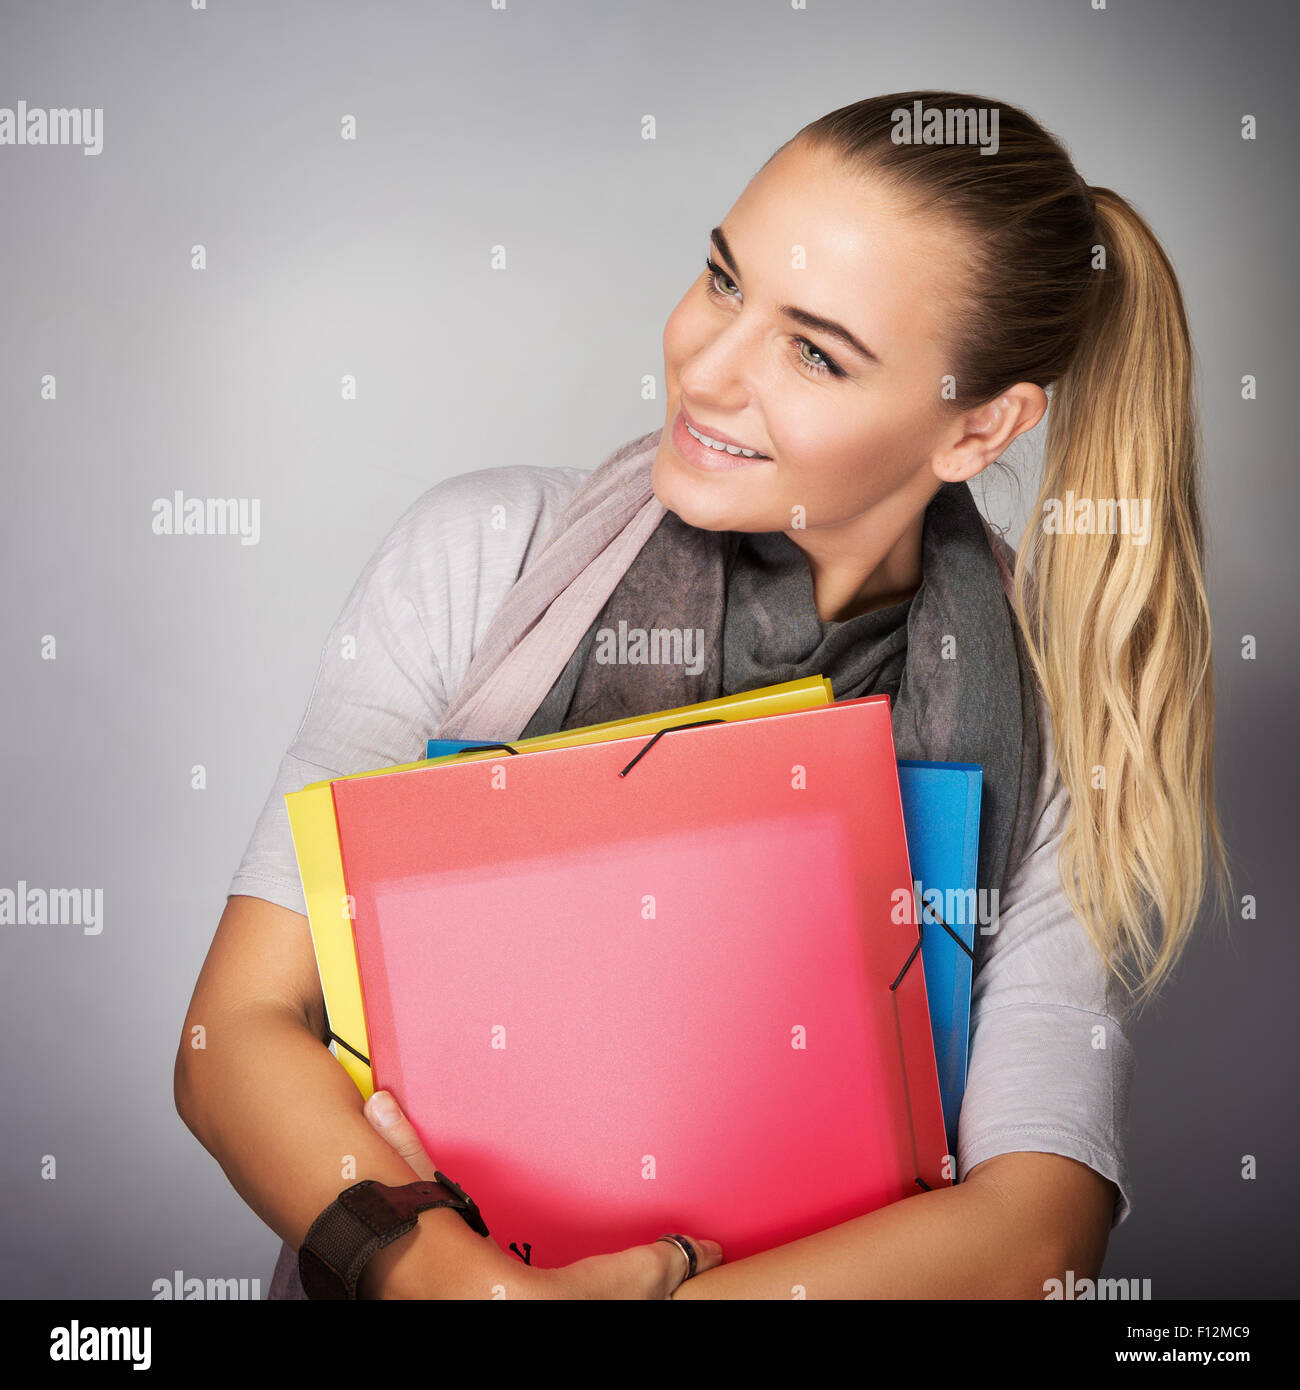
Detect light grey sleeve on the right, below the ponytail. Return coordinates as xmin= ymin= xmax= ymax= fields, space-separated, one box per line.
xmin=957 ymin=689 xmax=1135 ymax=1227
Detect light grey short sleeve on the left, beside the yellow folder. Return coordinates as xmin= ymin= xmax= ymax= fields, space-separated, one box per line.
xmin=227 ymin=466 xmax=587 ymax=915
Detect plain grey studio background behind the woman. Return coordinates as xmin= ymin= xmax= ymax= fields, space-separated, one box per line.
xmin=0 ymin=0 xmax=1300 ymax=1298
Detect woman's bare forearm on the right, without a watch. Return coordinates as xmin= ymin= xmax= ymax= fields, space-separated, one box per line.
xmin=673 ymin=1152 xmax=1115 ymax=1298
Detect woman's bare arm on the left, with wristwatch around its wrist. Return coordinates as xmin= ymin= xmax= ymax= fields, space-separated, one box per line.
xmin=175 ymin=895 xmax=535 ymax=1298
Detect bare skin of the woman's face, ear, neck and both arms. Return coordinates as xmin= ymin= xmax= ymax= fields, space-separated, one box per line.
xmin=175 ymin=135 xmax=1116 ymax=1300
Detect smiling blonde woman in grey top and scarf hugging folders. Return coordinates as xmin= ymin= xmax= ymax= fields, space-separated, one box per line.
xmin=177 ymin=92 xmax=1224 ymax=1298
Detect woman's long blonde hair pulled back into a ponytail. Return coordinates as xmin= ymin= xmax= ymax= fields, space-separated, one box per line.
xmin=783 ymin=92 xmax=1228 ymax=1001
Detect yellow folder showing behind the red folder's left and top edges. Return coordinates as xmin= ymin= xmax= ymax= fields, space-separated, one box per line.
xmin=285 ymin=676 xmax=834 ymax=1095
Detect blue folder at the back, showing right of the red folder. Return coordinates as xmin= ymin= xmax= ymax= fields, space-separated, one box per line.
xmin=424 ymin=738 xmax=983 ymax=1177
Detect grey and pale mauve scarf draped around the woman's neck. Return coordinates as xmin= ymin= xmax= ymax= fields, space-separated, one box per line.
xmin=437 ymin=431 xmax=1041 ymax=939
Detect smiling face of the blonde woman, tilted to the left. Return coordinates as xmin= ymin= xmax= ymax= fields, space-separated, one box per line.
xmin=652 ymin=135 xmax=964 ymax=536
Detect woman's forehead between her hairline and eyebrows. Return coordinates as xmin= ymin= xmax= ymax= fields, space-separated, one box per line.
xmin=722 ymin=142 xmax=966 ymax=359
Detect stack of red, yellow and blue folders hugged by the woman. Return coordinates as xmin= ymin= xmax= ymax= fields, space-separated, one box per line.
xmin=286 ymin=677 xmax=979 ymax=1266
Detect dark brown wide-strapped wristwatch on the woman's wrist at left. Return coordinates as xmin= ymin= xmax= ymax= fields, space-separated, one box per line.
xmin=298 ymin=1169 xmax=488 ymax=1298
